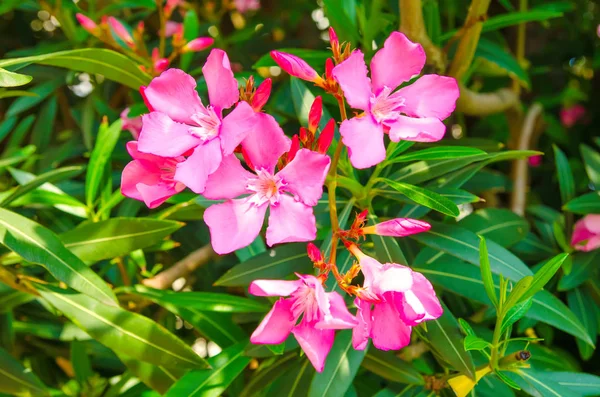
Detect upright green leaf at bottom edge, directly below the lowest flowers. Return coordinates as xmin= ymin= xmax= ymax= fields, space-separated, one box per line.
xmin=308 ymin=330 xmax=366 ymax=397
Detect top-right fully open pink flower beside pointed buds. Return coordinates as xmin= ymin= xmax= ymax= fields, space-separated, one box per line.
xmin=332 ymin=32 xmax=459 ymax=168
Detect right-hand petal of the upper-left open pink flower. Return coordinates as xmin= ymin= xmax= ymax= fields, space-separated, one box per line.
xmin=219 ymin=102 xmax=258 ymax=156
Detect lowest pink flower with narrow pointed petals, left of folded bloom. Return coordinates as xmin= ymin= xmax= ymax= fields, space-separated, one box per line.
xmin=249 ymin=274 xmax=358 ymax=372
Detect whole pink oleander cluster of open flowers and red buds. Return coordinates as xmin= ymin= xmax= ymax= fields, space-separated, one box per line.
xmin=121 ymin=30 xmax=458 ymax=371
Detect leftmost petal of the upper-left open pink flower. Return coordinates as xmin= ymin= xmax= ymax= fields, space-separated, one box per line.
xmin=138 ymin=112 xmax=202 ymax=157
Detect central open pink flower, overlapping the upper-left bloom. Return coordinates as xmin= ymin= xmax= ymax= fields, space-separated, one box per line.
xmin=203 ymin=120 xmax=330 ymax=254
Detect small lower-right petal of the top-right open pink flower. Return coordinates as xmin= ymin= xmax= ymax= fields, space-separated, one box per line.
xmin=389 ymin=116 xmax=446 ymax=142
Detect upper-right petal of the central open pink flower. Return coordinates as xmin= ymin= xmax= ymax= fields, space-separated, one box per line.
xmin=277 ymin=149 xmax=331 ymax=206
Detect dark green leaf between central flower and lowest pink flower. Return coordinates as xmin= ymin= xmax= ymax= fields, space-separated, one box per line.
xmin=215 ymin=244 xmax=312 ymax=287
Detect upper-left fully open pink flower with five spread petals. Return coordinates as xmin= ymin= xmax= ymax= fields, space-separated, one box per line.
xmin=139 ymin=49 xmax=262 ymax=193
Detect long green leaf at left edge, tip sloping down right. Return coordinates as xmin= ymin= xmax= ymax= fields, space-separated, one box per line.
xmin=0 ymin=208 xmax=117 ymax=305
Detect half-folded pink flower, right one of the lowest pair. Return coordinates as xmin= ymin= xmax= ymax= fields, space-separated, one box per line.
xmin=349 ymin=246 xmax=443 ymax=350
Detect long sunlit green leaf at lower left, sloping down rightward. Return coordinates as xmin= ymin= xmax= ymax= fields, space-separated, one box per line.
xmin=35 ymin=284 xmax=207 ymax=368
